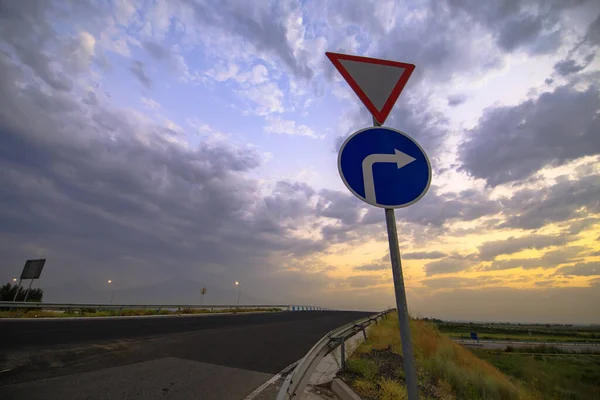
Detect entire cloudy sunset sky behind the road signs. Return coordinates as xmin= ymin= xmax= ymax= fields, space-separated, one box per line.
xmin=0 ymin=0 xmax=600 ymax=323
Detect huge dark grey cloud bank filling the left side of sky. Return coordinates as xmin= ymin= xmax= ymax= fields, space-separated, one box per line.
xmin=0 ymin=48 xmax=325 ymax=292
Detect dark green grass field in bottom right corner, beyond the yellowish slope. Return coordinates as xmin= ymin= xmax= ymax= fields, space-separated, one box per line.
xmin=473 ymin=349 xmax=600 ymax=400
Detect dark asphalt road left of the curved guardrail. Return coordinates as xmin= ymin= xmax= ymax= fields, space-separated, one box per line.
xmin=0 ymin=311 xmax=370 ymax=400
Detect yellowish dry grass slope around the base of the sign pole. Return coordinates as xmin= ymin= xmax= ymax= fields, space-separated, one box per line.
xmin=342 ymin=314 xmax=535 ymax=400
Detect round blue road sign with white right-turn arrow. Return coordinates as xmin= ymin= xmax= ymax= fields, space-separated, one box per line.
xmin=338 ymin=127 xmax=431 ymax=208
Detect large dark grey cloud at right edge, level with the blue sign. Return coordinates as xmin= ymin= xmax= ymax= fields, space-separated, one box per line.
xmin=459 ymin=84 xmax=600 ymax=186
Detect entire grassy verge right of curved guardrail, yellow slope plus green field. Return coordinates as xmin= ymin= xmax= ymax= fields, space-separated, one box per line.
xmin=341 ymin=314 xmax=600 ymax=400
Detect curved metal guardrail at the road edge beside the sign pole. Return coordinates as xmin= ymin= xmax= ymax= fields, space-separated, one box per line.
xmin=277 ymin=308 xmax=395 ymax=400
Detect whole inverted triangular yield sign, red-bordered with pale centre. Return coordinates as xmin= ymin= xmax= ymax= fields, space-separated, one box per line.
xmin=325 ymin=53 xmax=415 ymax=124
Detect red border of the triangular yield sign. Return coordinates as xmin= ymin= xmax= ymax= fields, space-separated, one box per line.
xmin=325 ymin=52 xmax=415 ymax=125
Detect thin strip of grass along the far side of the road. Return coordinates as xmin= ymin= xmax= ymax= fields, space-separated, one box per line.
xmin=0 ymin=308 xmax=280 ymax=318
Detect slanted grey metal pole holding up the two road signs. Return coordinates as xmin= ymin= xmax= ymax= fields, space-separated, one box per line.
xmin=373 ymin=117 xmax=419 ymax=400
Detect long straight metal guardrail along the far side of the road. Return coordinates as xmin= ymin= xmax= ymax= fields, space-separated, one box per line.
xmin=0 ymin=301 xmax=332 ymax=311
